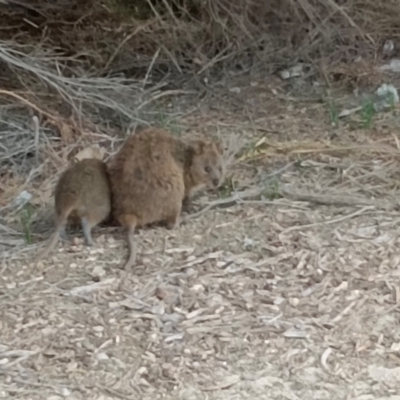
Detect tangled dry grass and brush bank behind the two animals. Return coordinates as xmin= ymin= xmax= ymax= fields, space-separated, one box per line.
xmin=0 ymin=0 xmax=397 ymax=177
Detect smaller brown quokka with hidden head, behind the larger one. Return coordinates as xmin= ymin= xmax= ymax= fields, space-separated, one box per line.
xmin=35 ymin=158 xmax=111 ymax=263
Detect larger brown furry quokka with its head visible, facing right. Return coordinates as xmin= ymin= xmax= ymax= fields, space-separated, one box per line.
xmin=109 ymin=128 xmax=222 ymax=270
